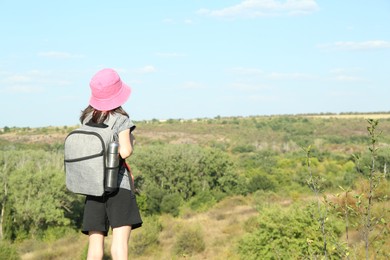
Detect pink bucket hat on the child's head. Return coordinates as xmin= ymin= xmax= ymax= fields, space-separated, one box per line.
xmin=89 ymin=69 xmax=131 ymax=111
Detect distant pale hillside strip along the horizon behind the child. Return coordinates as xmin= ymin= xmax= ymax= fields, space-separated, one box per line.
xmin=0 ymin=113 xmax=390 ymax=149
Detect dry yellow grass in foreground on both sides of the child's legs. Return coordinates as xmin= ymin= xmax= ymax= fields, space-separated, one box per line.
xmin=19 ymin=196 xmax=292 ymax=260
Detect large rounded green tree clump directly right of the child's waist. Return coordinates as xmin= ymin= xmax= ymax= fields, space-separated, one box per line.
xmin=132 ymin=145 xmax=238 ymax=214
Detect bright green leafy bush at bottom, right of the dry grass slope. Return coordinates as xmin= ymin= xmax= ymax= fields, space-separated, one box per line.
xmin=238 ymin=205 xmax=341 ymax=259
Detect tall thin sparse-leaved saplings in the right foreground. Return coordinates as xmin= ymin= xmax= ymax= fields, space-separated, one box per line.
xmin=304 ymin=119 xmax=388 ymax=259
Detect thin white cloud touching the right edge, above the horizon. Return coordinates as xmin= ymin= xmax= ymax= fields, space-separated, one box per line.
xmin=319 ymin=40 xmax=390 ymax=51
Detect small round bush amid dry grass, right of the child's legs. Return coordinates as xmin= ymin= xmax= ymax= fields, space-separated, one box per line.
xmin=173 ymin=227 xmax=206 ymax=256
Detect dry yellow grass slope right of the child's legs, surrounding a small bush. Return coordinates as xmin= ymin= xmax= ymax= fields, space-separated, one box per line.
xmin=126 ymin=196 xmax=258 ymax=260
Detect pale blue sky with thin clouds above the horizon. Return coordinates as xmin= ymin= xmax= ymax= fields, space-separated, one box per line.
xmin=0 ymin=0 xmax=390 ymax=127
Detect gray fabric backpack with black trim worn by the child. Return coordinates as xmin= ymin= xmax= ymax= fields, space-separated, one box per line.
xmin=64 ymin=115 xmax=117 ymax=196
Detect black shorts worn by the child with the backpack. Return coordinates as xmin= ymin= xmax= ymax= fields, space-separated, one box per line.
xmin=81 ymin=189 xmax=142 ymax=236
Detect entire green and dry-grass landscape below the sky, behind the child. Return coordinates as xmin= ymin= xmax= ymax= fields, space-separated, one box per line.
xmin=0 ymin=114 xmax=390 ymax=259
